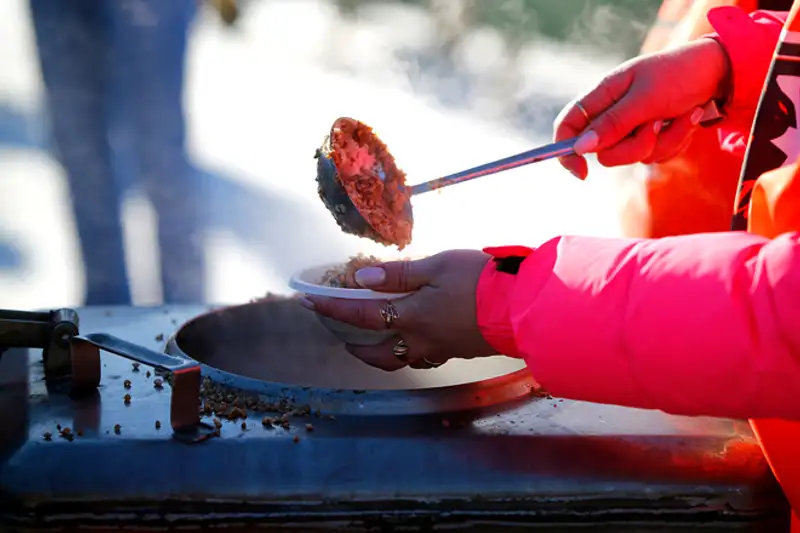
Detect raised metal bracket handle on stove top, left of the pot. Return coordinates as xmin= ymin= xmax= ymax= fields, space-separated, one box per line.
xmin=71 ymin=333 xmax=214 ymax=442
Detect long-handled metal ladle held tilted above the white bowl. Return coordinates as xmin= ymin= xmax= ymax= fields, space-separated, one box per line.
xmin=316 ymin=102 xmax=722 ymax=244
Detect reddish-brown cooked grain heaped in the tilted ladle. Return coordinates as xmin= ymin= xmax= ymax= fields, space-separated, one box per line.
xmin=320 ymin=118 xmax=413 ymax=250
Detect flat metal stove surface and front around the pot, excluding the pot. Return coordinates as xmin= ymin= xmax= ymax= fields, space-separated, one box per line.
xmin=0 ymin=307 xmax=788 ymax=532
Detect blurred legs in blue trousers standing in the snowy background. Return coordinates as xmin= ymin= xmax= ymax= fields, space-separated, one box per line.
xmin=30 ymin=0 xmax=205 ymax=305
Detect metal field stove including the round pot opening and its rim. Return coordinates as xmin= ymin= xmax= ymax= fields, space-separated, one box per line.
xmin=0 ymin=303 xmax=788 ymax=532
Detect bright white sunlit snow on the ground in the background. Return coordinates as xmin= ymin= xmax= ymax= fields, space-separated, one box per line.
xmin=0 ymin=0 xmax=618 ymax=308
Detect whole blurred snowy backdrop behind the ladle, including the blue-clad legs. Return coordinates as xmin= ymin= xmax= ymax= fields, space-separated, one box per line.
xmin=0 ymin=0 xmax=660 ymax=309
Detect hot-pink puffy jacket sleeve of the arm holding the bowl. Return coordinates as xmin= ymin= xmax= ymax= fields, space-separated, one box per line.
xmin=477 ymin=233 xmax=800 ymax=420
